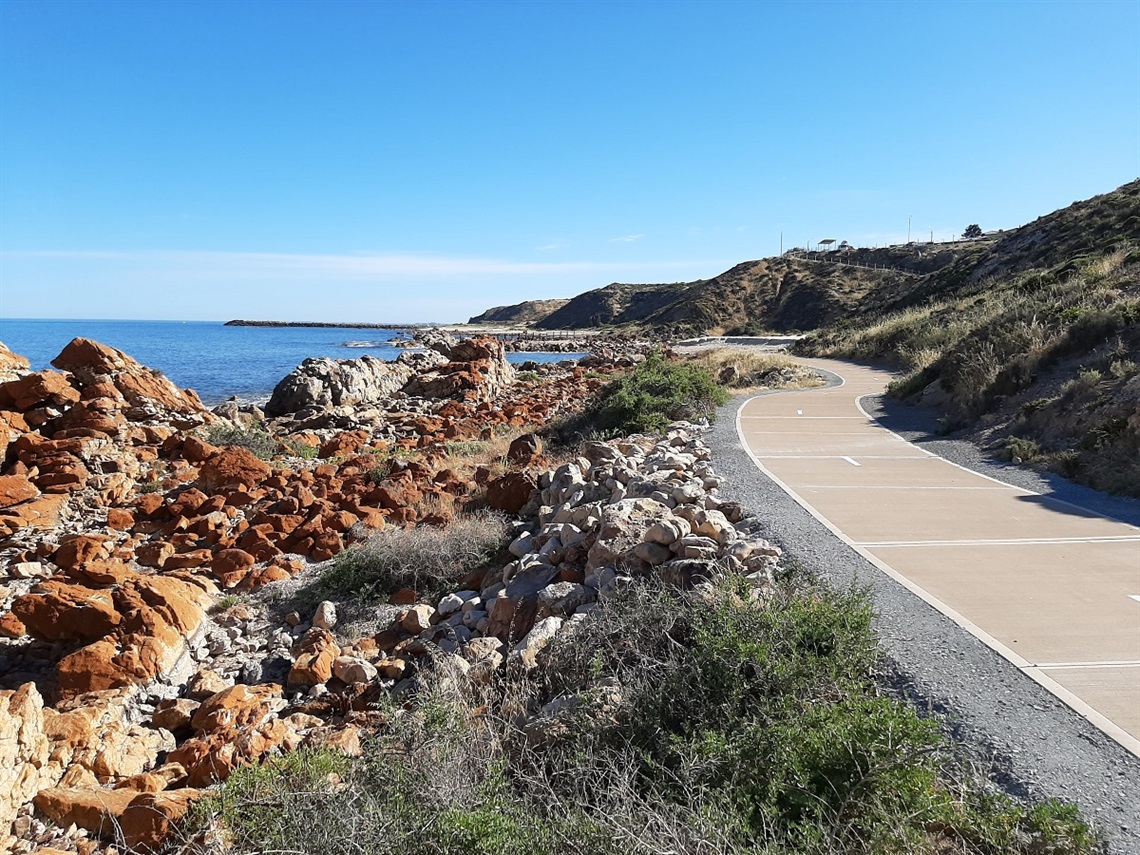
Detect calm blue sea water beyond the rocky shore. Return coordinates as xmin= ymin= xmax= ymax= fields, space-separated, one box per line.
xmin=0 ymin=318 xmax=580 ymax=406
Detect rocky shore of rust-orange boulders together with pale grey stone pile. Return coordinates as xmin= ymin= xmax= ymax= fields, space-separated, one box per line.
xmin=0 ymin=335 xmax=743 ymax=855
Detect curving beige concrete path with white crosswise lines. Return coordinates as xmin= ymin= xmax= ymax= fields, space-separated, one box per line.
xmin=736 ymin=359 xmax=1140 ymax=755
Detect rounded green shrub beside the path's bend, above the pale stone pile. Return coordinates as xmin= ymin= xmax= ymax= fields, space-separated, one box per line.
xmin=563 ymin=352 xmax=728 ymax=437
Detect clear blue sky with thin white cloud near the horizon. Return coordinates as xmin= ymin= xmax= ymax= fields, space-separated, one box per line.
xmin=0 ymin=0 xmax=1140 ymax=321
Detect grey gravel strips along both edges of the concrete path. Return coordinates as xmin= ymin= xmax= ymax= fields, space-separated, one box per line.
xmin=708 ymin=380 xmax=1140 ymax=855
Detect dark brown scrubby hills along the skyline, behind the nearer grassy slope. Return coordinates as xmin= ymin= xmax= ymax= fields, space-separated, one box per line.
xmin=490 ymin=180 xmax=1140 ymax=344
